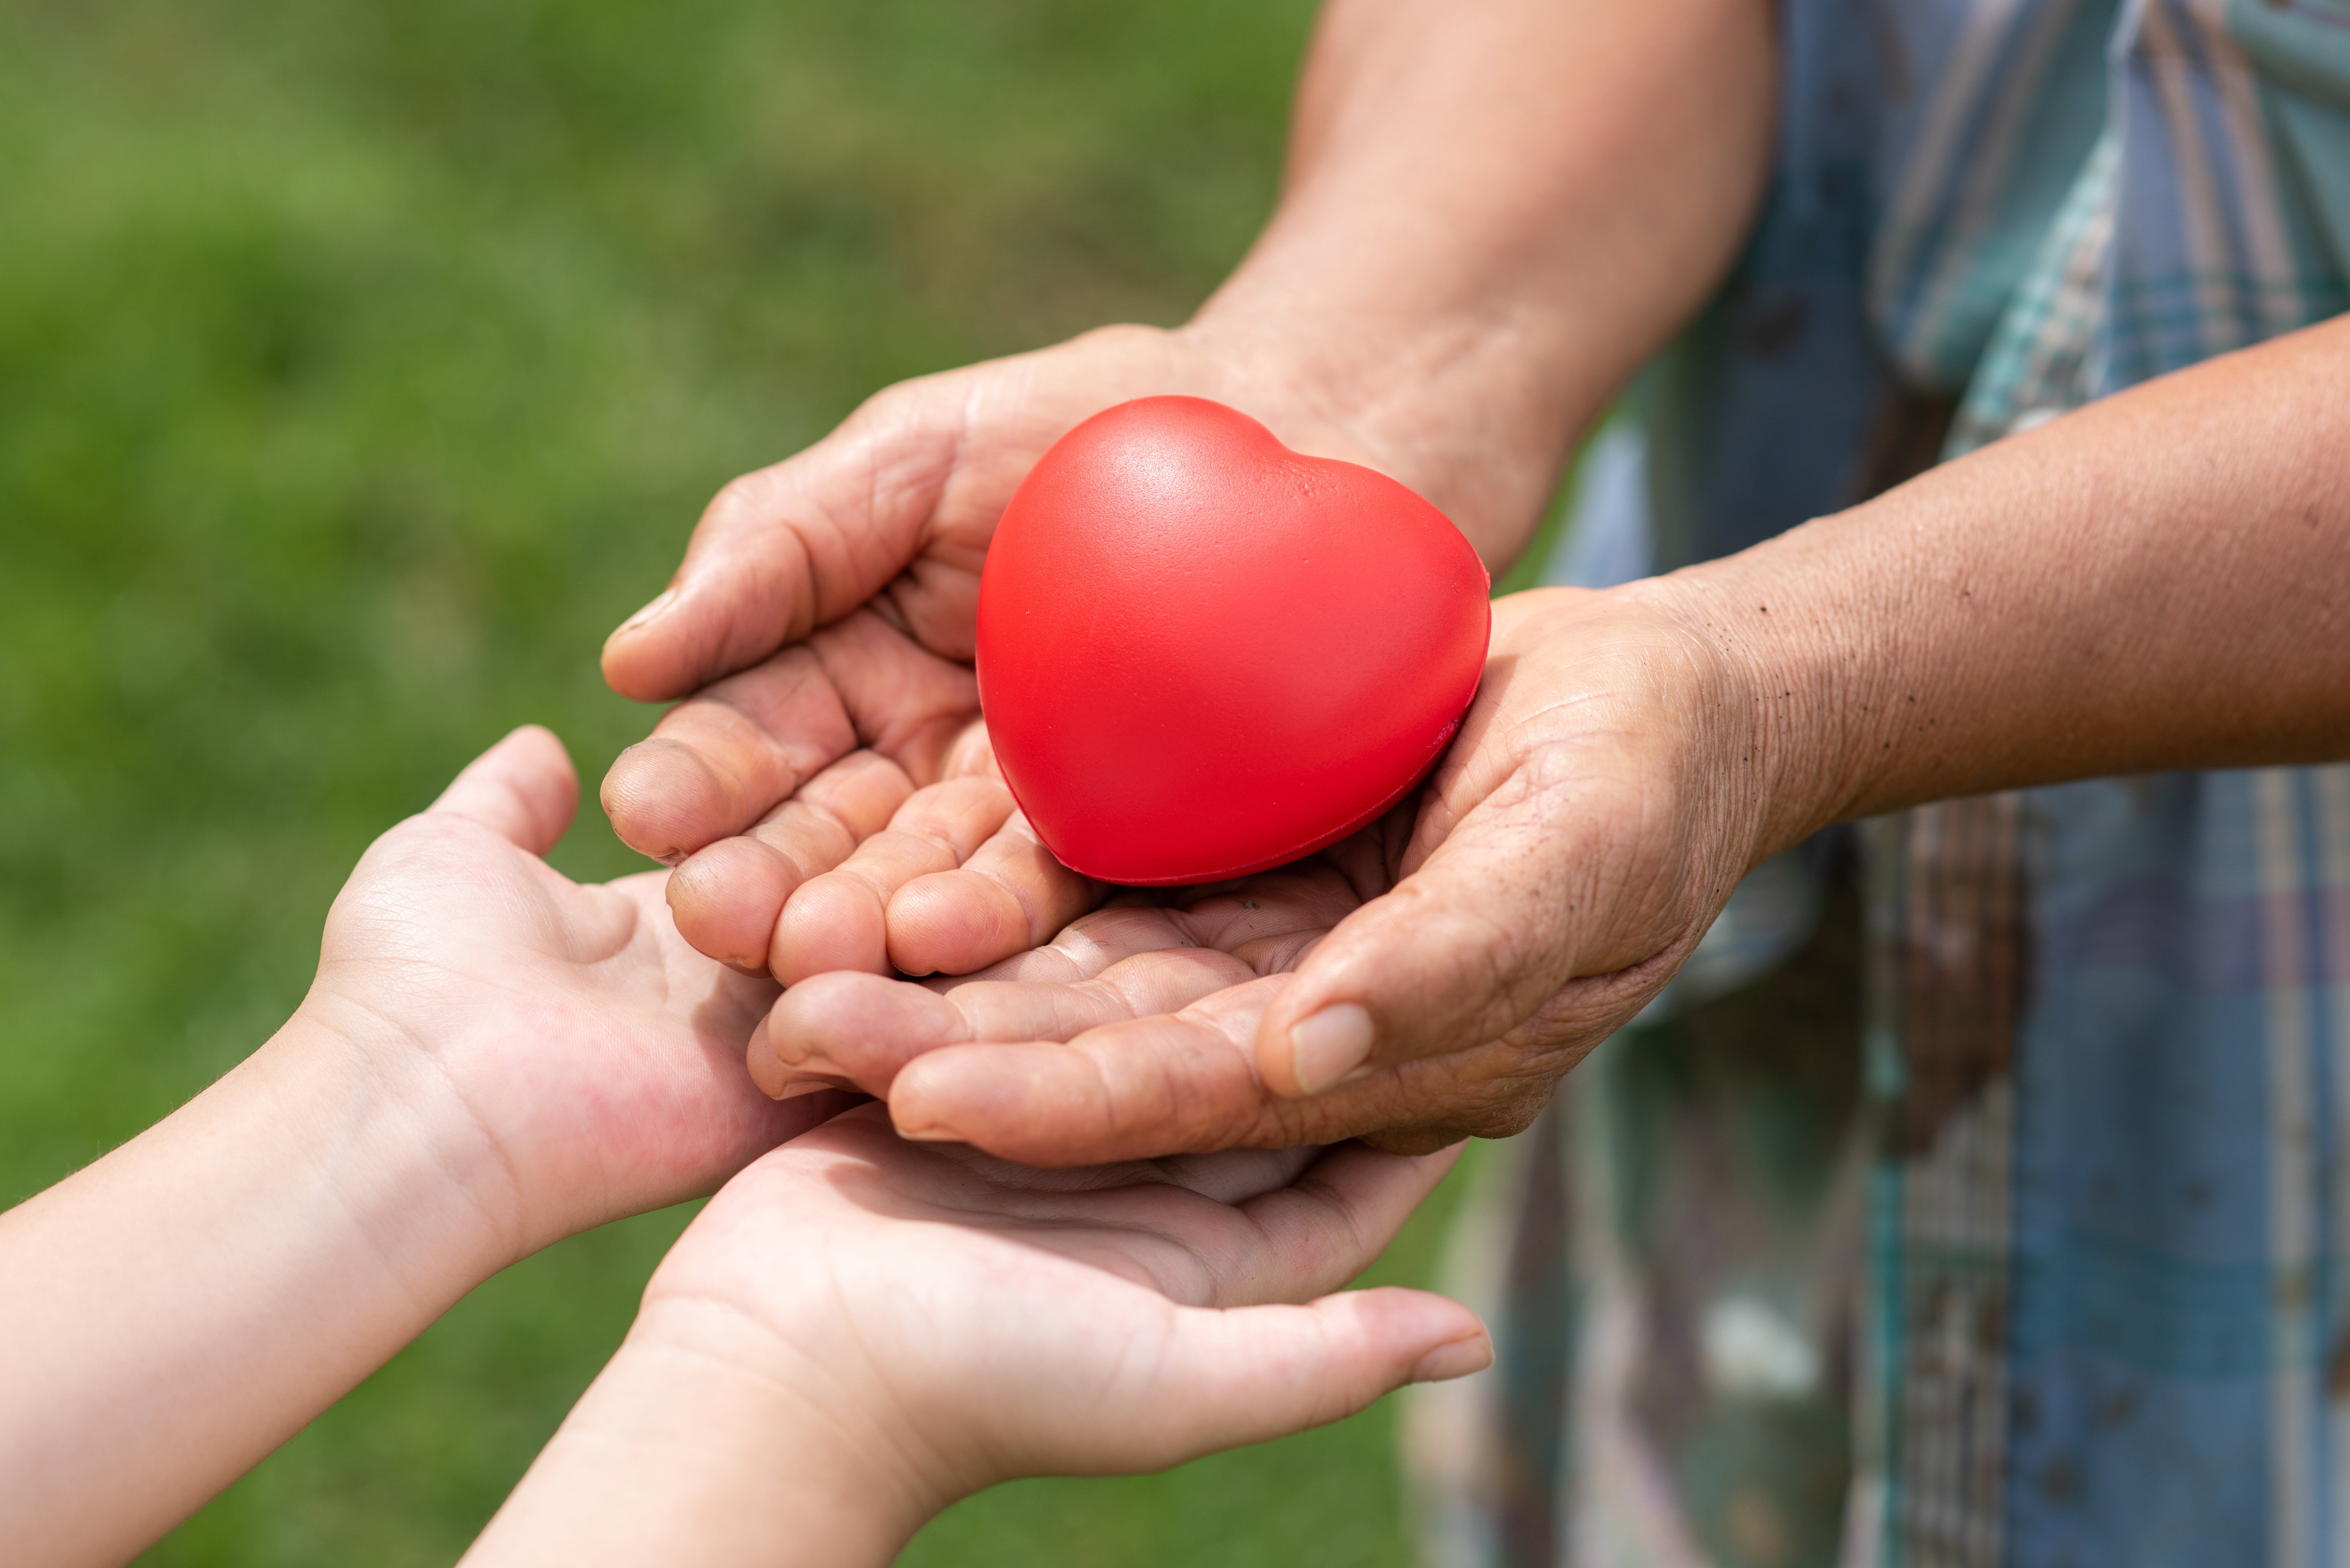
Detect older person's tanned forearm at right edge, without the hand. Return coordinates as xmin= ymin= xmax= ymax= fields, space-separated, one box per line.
xmin=1621 ymin=317 xmax=2350 ymax=846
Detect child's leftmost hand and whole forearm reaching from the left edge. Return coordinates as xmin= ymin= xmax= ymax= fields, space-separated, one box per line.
xmin=0 ymin=729 xmax=841 ymax=1563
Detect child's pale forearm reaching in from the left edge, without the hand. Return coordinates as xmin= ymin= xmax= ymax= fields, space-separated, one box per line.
xmin=0 ymin=1018 xmax=508 ymax=1566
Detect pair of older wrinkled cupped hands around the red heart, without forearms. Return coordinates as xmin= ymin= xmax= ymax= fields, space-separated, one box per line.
xmin=604 ymin=327 xmax=1762 ymax=1164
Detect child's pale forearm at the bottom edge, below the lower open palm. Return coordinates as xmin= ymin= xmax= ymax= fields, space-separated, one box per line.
xmin=463 ymin=1302 xmax=947 ymax=1568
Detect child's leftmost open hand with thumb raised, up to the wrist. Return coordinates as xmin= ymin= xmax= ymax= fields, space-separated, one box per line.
xmin=296 ymin=729 xmax=839 ymax=1255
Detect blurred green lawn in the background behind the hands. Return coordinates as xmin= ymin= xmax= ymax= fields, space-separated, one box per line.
xmin=0 ymin=0 xmax=1494 ymax=1568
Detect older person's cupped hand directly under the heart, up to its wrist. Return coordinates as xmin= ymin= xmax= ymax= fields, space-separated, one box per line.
xmin=750 ymin=590 xmax=1781 ymax=1164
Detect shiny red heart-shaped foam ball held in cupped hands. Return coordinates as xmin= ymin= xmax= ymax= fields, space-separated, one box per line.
xmin=980 ymin=397 xmax=1492 ymax=884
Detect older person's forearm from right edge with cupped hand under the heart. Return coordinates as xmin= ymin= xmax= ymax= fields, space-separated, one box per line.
xmin=602 ymin=310 xmax=2350 ymax=1164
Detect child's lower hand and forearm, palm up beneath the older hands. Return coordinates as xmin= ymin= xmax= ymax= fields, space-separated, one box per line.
xmin=468 ymin=1107 xmax=1490 ymax=1568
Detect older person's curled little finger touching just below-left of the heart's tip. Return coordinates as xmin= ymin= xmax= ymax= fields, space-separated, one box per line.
xmin=888 ymin=811 xmax=1104 ymax=976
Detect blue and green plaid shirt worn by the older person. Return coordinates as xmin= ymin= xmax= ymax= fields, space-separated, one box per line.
xmin=1408 ymin=0 xmax=2350 ymax=1568
